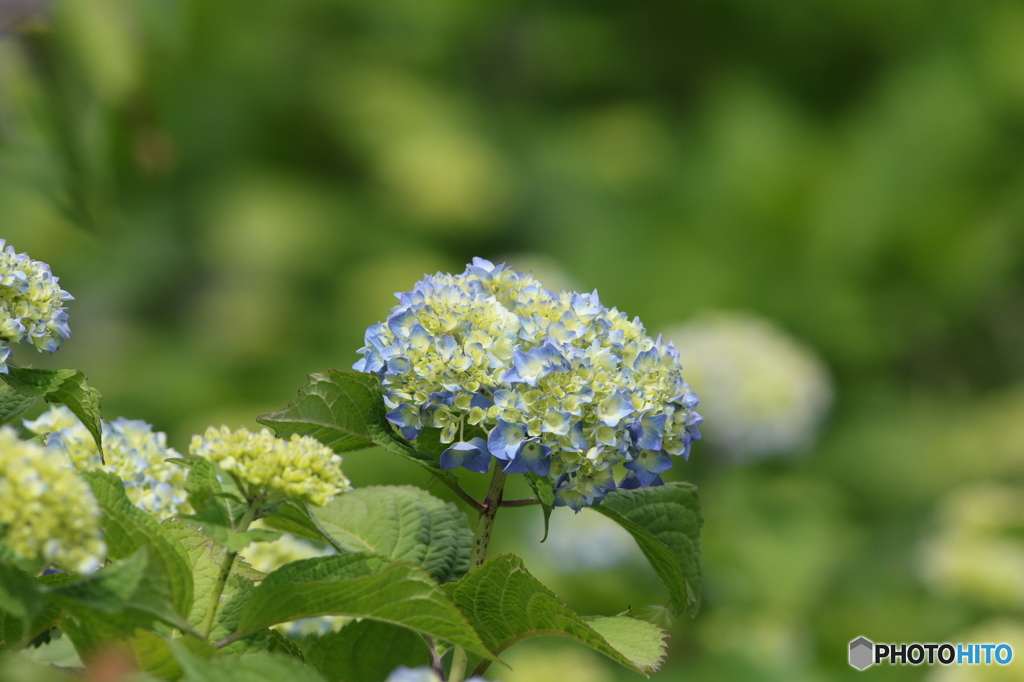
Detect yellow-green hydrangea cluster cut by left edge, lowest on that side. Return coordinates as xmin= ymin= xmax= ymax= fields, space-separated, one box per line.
xmin=0 ymin=426 xmax=106 ymax=572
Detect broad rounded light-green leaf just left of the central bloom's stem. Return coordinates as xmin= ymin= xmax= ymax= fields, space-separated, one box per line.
xmin=288 ymin=485 xmax=473 ymax=583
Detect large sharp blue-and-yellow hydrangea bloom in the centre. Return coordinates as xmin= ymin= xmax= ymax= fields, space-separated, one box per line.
xmin=354 ymin=258 xmax=700 ymax=510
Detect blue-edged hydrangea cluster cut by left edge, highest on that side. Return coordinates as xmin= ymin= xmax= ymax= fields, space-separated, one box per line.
xmin=0 ymin=240 xmax=74 ymax=374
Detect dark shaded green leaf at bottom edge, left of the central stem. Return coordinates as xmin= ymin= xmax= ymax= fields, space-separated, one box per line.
xmin=302 ymin=621 xmax=430 ymax=682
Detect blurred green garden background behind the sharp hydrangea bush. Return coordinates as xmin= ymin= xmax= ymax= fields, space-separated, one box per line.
xmin=0 ymin=0 xmax=1024 ymax=682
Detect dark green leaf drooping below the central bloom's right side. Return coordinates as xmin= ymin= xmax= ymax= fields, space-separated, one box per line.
xmin=592 ymin=483 xmax=703 ymax=615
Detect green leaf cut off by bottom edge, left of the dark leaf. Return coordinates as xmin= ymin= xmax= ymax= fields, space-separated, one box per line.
xmin=172 ymin=642 xmax=325 ymax=682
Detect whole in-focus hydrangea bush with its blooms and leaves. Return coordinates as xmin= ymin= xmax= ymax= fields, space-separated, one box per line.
xmin=0 ymin=245 xmax=701 ymax=682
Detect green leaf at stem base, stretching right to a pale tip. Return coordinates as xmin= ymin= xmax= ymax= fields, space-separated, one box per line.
xmin=444 ymin=554 xmax=653 ymax=673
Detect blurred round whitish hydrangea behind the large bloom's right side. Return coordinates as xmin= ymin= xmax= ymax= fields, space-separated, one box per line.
xmin=665 ymin=313 xmax=833 ymax=461
